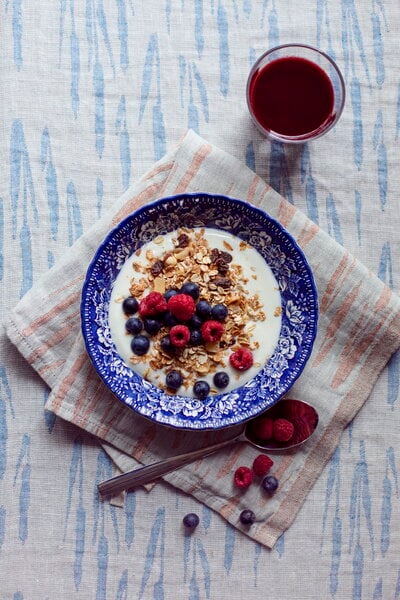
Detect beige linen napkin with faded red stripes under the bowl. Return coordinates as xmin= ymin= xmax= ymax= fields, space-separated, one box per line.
xmin=6 ymin=131 xmax=400 ymax=547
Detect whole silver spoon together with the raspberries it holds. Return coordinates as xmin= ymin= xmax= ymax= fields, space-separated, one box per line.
xmin=97 ymin=398 xmax=318 ymax=496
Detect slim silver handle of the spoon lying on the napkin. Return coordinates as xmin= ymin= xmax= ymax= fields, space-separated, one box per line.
xmin=97 ymin=435 xmax=244 ymax=496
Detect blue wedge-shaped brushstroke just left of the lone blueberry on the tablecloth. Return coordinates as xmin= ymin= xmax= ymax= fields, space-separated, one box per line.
xmin=139 ymin=508 xmax=165 ymax=600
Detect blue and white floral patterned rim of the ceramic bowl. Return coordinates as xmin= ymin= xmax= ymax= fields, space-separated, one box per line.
xmin=81 ymin=193 xmax=318 ymax=430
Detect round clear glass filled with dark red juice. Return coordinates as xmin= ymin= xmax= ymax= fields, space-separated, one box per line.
xmin=247 ymin=45 xmax=344 ymax=142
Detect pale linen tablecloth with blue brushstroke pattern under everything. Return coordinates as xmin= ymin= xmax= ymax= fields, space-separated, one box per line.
xmin=0 ymin=0 xmax=400 ymax=600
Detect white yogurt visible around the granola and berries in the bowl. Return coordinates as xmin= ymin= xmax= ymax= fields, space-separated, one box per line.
xmin=109 ymin=228 xmax=281 ymax=396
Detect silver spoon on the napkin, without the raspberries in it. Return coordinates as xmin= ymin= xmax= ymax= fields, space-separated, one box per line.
xmin=97 ymin=399 xmax=318 ymax=496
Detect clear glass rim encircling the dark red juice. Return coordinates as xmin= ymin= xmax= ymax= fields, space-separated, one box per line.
xmin=246 ymin=43 xmax=346 ymax=143
